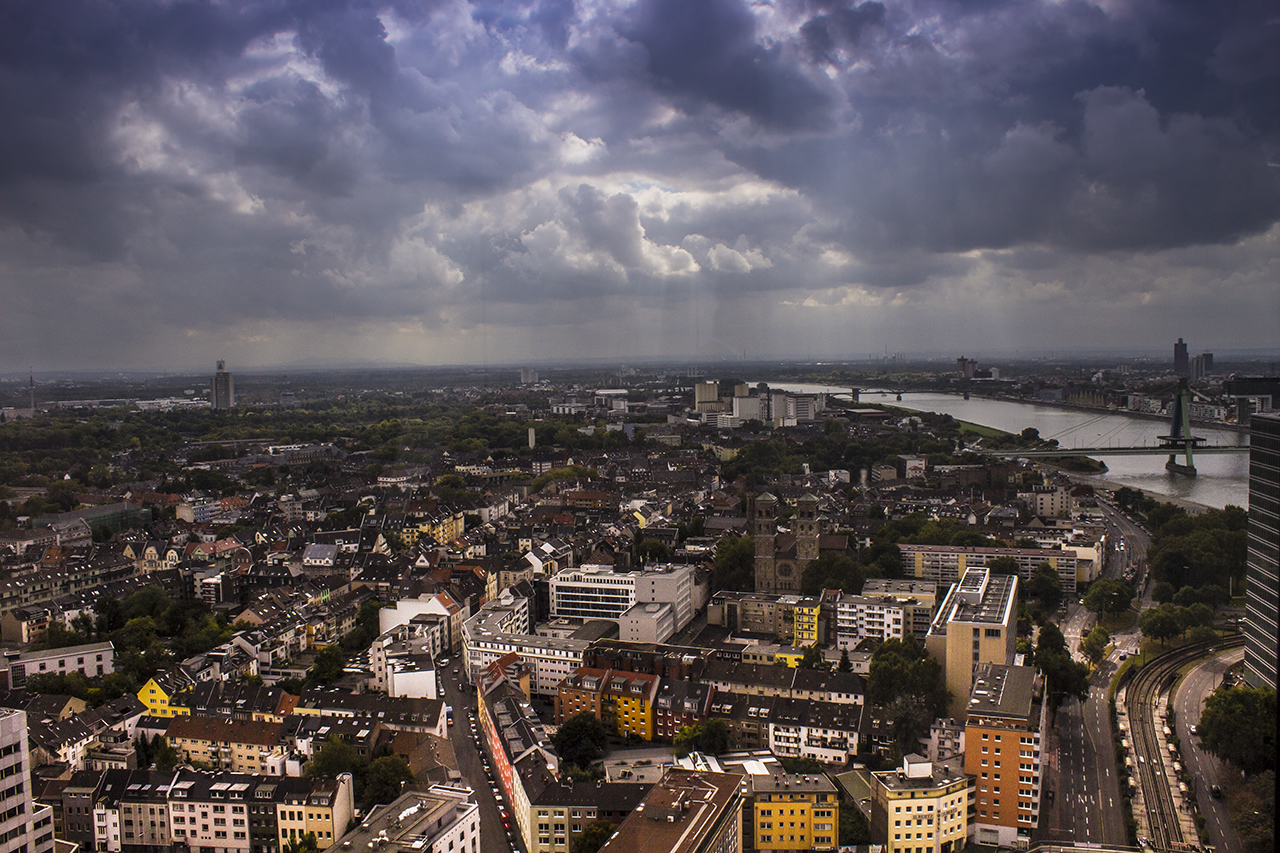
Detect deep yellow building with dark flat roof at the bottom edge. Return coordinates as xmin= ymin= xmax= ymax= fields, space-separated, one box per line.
xmin=751 ymin=774 xmax=840 ymax=853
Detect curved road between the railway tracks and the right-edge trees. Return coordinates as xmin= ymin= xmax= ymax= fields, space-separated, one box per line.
xmin=1174 ymin=648 xmax=1244 ymax=852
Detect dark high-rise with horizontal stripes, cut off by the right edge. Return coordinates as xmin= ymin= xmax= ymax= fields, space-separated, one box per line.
xmin=1244 ymin=415 xmax=1280 ymax=690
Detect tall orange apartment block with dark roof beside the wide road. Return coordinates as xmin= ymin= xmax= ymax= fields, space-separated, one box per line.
xmin=964 ymin=663 xmax=1048 ymax=847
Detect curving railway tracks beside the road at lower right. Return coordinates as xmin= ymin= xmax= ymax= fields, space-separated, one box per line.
xmin=1125 ymin=637 xmax=1244 ymax=850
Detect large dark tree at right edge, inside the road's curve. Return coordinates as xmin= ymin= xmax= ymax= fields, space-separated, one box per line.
xmin=1199 ymin=686 xmax=1276 ymax=775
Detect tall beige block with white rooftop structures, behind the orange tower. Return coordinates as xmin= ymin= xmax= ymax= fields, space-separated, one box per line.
xmin=924 ymin=569 xmax=1018 ymax=720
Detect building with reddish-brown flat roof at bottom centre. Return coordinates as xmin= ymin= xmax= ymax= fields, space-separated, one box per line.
xmin=600 ymin=767 xmax=742 ymax=853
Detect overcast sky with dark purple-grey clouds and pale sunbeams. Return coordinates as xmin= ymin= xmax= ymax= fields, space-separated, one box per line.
xmin=0 ymin=0 xmax=1280 ymax=373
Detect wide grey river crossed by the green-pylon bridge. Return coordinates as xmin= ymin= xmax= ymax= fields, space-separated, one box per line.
xmin=769 ymin=383 xmax=1249 ymax=508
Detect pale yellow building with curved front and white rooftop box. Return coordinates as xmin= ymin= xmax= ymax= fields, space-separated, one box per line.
xmin=870 ymin=754 xmax=973 ymax=853
